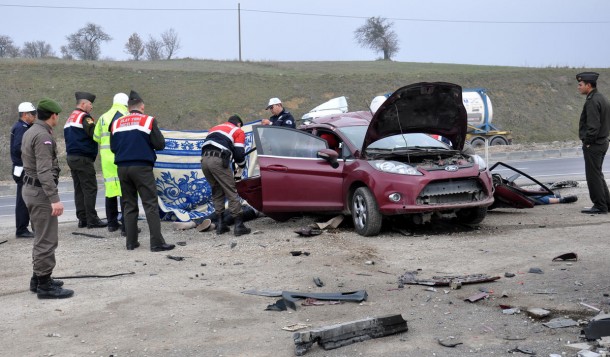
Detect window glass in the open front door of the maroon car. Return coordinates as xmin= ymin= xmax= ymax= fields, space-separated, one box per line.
xmin=256 ymin=126 xmax=327 ymax=158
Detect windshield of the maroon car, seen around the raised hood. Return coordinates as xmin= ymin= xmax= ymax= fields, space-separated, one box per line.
xmin=340 ymin=125 xmax=451 ymax=151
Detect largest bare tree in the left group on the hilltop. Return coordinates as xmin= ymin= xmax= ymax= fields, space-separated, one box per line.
xmin=66 ymin=23 xmax=112 ymax=61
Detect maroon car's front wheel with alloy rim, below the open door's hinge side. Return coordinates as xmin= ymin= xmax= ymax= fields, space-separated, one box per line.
xmin=352 ymin=187 xmax=383 ymax=237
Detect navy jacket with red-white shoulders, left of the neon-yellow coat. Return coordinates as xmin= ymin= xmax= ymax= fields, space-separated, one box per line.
xmin=64 ymin=109 xmax=98 ymax=160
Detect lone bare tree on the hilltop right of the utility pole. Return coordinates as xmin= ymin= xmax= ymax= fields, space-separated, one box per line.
xmin=354 ymin=17 xmax=399 ymax=60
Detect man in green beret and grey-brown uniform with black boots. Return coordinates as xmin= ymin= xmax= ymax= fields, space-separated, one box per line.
xmin=21 ymin=98 xmax=74 ymax=299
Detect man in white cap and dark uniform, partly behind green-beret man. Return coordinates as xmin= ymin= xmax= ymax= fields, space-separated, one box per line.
xmin=11 ymin=102 xmax=36 ymax=238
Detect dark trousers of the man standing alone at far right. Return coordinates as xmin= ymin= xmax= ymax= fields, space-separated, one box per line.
xmin=582 ymin=142 xmax=610 ymax=212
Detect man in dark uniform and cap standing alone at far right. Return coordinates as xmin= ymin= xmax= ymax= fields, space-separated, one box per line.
xmin=576 ymin=72 xmax=610 ymax=214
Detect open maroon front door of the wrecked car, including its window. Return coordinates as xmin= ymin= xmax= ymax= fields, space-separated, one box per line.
xmin=253 ymin=125 xmax=343 ymax=212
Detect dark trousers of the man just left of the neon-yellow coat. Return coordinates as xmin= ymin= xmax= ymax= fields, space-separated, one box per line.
xmin=66 ymin=155 xmax=99 ymax=222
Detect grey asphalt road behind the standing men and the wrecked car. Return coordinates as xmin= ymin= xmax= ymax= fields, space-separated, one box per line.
xmin=0 ymin=157 xmax=610 ymax=226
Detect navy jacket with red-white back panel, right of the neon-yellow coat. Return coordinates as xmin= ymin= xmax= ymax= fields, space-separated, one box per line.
xmin=110 ymin=110 xmax=165 ymax=166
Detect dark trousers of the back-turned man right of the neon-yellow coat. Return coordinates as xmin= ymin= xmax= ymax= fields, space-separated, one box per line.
xmin=118 ymin=166 xmax=165 ymax=247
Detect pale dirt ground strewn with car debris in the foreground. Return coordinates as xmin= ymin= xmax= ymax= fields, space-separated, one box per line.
xmin=0 ymin=183 xmax=610 ymax=357
